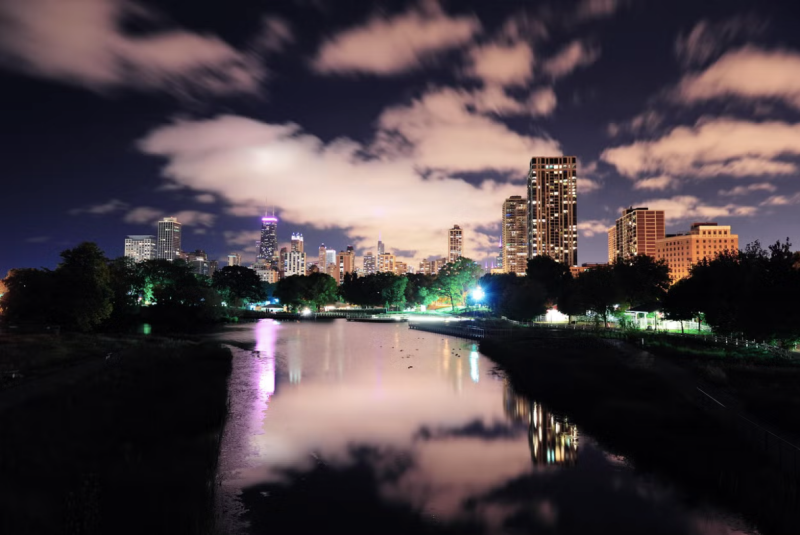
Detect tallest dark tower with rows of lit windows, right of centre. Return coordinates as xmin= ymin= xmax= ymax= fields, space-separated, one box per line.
xmin=528 ymin=156 xmax=578 ymax=266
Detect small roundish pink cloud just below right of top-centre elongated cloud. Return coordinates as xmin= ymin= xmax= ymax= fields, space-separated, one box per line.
xmin=467 ymin=41 xmax=534 ymax=86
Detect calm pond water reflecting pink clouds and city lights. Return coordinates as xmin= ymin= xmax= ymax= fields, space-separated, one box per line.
xmin=209 ymin=320 xmax=754 ymax=535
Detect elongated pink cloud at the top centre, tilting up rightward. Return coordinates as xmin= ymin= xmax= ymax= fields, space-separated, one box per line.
xmin=313 ymin=0 xmax=481 ymax=76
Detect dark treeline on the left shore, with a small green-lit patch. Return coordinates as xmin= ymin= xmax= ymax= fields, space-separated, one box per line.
xmin=0 ymin=242 xmax=267 ymax=332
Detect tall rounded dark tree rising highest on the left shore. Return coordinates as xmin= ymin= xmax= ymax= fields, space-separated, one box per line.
xmin=55 ymin=242 xmax=113 ymax=331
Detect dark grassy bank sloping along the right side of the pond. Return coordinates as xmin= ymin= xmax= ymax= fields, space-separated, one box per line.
xmin=481 ymin=338 xmax=800 ymax=534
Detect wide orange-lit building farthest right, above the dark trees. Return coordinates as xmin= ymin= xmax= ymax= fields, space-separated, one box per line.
xmin=655 ymin=223 xmax=739 ymax=283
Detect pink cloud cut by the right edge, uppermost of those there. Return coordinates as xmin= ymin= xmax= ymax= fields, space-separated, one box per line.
xmin=675 ymin=46 xmax=800 ymax=108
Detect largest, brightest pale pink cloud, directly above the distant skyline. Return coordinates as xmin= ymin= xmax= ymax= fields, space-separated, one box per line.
xmin=140 ymin=112 xmax=558 ymax=261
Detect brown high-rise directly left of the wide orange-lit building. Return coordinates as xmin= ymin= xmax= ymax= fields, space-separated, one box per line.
xmin=608 ymin=208 xmax=665 ymax=262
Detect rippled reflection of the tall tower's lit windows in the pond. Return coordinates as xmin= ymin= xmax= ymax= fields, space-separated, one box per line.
xmin=503 ymin=380 xmax=578 ymax=466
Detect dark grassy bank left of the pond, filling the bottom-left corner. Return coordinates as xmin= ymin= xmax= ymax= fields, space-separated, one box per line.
xmin=0 ymin=338 xmax=231 ymax=534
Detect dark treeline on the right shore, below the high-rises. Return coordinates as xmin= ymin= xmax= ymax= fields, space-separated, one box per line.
xmin=480 ymin=240 xmax=800 ymax=347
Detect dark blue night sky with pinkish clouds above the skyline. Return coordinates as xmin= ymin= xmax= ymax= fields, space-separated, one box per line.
xmin=0 ymin=0 xmax=800 ymax=273
